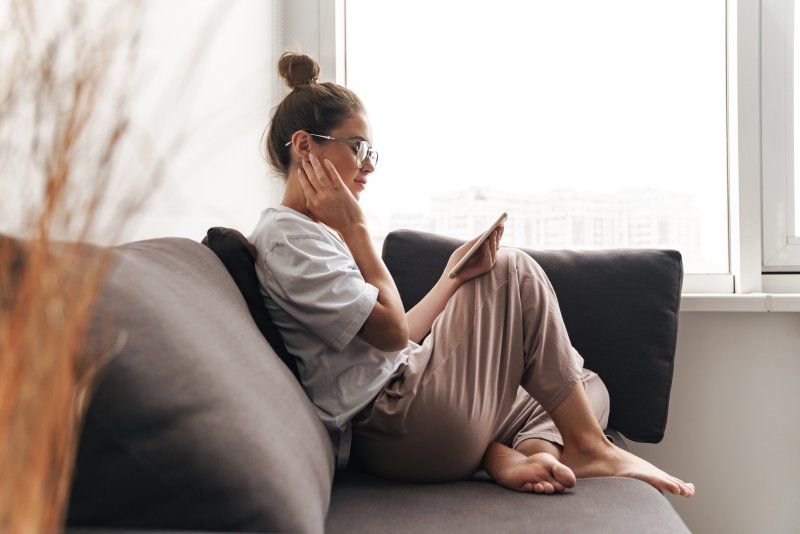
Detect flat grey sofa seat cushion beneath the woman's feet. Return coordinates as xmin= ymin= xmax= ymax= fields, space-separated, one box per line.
xmin=325 ymin=471 xmax=689 ymax=534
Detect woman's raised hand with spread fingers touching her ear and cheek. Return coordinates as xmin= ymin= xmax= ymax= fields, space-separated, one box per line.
xmin=297 ymin=154 xmax=365 ymax=233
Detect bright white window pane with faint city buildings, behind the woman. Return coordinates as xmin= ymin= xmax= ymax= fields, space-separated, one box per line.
xmin=347 ymin=0 xmax=728 ymax=272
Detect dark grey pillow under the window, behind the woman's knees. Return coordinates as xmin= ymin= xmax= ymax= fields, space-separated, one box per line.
xmin=383 ymin=230 xmax=683 ymax=443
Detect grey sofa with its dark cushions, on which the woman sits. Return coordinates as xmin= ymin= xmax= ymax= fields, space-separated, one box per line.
xmin=59 ymin=229 xmax=687 ymax=533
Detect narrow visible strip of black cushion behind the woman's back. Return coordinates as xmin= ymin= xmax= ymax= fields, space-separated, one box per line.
xmin=202 ymin=227 xmax=300 ymax=380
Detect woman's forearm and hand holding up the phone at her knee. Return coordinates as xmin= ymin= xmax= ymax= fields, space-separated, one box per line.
xmin=406 ymin=225 xmax=503 ymax=343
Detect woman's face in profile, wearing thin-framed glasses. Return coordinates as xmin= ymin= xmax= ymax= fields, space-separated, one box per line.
xmin=311 ymin=113 xmax=375 ymax=200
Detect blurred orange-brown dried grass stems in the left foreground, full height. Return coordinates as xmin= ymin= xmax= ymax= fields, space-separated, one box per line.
xmin=0 ymin=0 xmax=148 ymax=534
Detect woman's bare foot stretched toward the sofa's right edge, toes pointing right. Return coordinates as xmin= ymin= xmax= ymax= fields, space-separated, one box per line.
xmin=561 ymin=440 xmax=694 ymax=497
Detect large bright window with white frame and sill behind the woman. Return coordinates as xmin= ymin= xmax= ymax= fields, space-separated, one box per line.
xmin=296 ymin=0 xmax=800 ymax=298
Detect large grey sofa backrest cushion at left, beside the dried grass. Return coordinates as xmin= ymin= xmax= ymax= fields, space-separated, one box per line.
xmin=68 ymin=238 xmax=334 ymax=532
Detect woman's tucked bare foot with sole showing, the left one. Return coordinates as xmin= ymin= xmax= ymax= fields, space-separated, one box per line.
xmin=483 ymin=443 xmax=575 ymax=494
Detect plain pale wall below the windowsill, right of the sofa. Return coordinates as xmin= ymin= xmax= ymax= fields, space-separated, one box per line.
xmin=631 ymin=312 xmax=800 ymax=534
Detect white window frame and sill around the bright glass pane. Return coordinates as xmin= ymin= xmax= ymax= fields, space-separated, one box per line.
xmin=282 ymin=0 xmax=800 ymax=295
